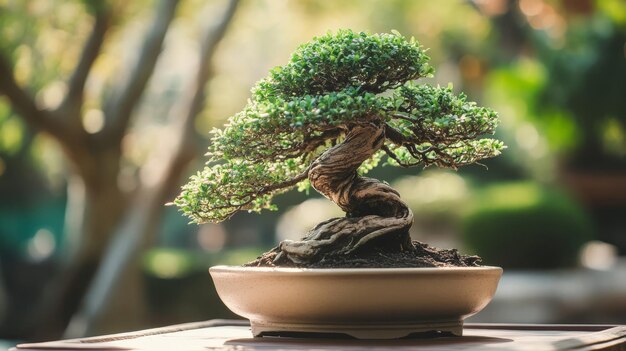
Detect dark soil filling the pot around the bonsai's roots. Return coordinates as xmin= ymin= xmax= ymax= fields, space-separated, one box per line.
xmin=244 ymin=241 xmax=481 ymax=268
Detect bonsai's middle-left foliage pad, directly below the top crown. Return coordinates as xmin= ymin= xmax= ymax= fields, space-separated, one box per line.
xmin=209 ymin=88 xmax=382 ymax=160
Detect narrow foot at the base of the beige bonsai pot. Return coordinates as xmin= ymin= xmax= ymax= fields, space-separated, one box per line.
xmin=250 ymin=321 xmax=463 ymax=339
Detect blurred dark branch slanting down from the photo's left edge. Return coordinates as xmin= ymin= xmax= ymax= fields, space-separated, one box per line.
xmin=0 ymin=54 xmax=72 ymax=145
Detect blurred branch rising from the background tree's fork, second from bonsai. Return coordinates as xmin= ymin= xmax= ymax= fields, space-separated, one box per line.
xmin=105 ymin=0 xmax=179 ymax=141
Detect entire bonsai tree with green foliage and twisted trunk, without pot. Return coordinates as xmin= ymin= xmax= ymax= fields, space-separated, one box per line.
xmin=174 ymin=30 xmax=504 ymax=267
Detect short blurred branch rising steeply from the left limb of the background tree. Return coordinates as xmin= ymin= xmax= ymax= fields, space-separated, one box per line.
xmin=59 ymin=5 xmax=111 ymax=123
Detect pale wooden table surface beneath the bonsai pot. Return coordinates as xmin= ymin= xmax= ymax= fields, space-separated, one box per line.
xmin=12 ymin=320 xmax=626 ymax=351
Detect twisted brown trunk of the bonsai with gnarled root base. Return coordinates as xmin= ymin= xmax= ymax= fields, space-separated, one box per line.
xmin=274 ymin=124 xmax=414 ymax=265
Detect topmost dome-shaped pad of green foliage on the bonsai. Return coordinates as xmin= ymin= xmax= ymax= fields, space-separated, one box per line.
xmin=253 ymin=30 xmax=433 ymax=100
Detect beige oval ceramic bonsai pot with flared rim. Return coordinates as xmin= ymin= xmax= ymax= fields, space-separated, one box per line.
xmin=209 ymin=266 xmax=502 ymax=339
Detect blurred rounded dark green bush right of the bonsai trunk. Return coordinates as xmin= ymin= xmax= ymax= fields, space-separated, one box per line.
xmin=462 ymin=183 xmax=593 ymax=269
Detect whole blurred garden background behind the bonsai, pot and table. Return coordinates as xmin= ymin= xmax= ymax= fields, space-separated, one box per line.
xmin=0 ymin=0 xmax=626 ymax=348
